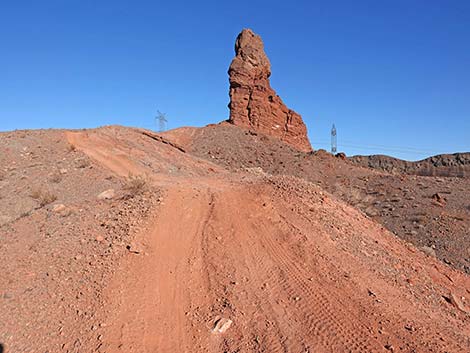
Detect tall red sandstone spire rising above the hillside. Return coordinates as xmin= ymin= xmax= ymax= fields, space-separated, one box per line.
xmin=228 ymin=29 xmax=312 ymax=152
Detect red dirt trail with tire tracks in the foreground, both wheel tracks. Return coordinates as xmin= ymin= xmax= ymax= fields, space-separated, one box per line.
xmin=102 ymin=185 xmax=379 ymax=352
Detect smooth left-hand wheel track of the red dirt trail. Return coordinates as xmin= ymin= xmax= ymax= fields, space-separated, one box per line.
xmin=103 ymin=183 xmax=210 ymax=352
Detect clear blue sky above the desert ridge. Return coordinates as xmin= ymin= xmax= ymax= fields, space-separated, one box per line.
xmin=0 ymin=0 xmax=470 ymax=159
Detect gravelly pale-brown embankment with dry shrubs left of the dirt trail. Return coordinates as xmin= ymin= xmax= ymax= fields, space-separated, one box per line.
xmin=0 ymin=130 xmax=159 ymax=352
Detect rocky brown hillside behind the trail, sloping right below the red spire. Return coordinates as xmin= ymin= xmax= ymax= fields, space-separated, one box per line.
xmin=164 ymin=123 xmax=470 ymax=273
